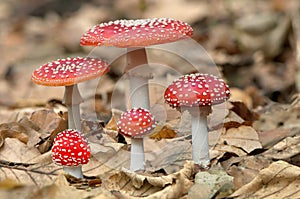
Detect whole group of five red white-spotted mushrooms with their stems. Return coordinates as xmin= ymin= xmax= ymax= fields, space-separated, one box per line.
xmin=31 ymin=18 xmax=230 ymax=178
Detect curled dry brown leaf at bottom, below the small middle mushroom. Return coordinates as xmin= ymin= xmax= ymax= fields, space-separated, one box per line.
xmin=105 ymin=161 xmax=194 ymax=198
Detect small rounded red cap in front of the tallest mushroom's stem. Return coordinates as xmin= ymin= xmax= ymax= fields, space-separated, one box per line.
xmin=117 ymin=108 xmax=155 ymax=138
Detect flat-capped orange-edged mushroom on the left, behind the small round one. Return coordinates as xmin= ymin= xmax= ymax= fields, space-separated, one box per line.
xmin=31 ymin=57 xmax=109 ymax=131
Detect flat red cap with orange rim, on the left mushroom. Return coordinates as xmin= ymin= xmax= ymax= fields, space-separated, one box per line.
xmin=31 ymin=57 xmax=109 ymax=86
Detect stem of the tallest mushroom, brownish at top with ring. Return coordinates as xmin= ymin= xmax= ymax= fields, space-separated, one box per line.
xmin=126 ymin=48 xmax=152 ymax=110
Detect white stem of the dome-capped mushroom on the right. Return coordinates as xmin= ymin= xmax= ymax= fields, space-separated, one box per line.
xmin=186 ymin=107 xmax=210 ymax=167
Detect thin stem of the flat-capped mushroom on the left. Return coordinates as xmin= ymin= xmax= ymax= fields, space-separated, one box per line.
xmin=63 ymin=84 xmax=83 ymax=131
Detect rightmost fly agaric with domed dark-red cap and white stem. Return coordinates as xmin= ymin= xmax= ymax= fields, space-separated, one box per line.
xmin=164 ymin=73 xmax=230 ymax=167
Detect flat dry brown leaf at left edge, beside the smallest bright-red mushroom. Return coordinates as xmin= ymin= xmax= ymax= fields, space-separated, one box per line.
xmin=0 ymin=138 xmax=58 ymax=186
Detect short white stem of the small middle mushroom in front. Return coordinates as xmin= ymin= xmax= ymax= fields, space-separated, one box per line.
xmin=130 ymin=138 xmax=145 ymax=171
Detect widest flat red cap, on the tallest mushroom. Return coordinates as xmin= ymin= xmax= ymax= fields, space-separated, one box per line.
xmin=80 ymin=18 xmax=193 ymax=48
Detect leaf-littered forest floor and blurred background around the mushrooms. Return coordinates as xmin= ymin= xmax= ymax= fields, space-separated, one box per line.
xmin=0 ymin=0 xmax=300 ymax=199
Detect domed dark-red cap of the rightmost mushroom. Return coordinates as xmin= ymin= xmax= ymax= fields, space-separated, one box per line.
xmin=164 ymin=73 xmax=230 ymax=108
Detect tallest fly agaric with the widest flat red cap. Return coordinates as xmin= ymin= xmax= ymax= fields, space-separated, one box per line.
xmin=80 ymin=18 xmax=193 ymax=109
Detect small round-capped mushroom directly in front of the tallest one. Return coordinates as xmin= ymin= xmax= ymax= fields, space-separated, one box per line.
xmin=117 ymin=108 xmax=155 ymax=171
